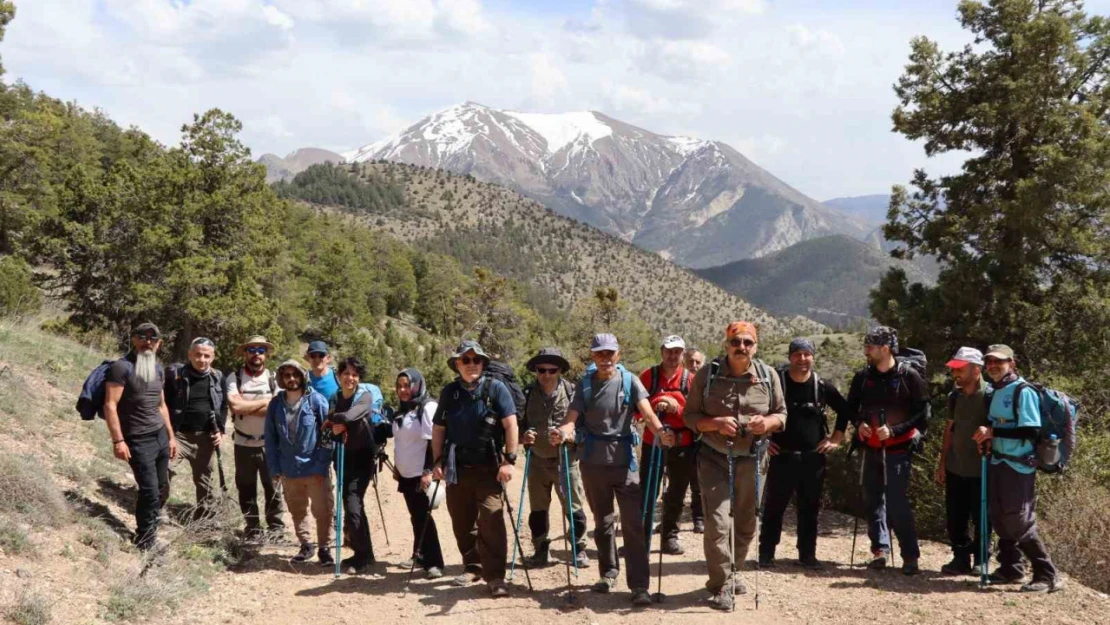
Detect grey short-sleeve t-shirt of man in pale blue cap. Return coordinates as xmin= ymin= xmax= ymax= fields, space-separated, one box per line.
xmin=569 ymin=372 xmax=649 ymax=466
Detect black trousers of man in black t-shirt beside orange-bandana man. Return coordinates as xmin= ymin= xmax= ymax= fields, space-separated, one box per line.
xmin=759 ymin=452 xmax=826 ymax=558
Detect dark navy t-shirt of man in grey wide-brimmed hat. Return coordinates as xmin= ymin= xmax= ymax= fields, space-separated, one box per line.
xmin=432 ymin=377 xmax=516 ymax=465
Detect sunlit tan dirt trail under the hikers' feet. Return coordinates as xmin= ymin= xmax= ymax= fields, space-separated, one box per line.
xmin=152 ymin=455 xmax=1110 ymax=625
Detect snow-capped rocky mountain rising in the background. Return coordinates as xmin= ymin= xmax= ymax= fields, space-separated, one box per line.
xmin=344 ymin=102 xmax=870 ymax=268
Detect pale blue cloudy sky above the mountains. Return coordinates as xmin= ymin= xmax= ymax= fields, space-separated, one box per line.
xmin=8 ymin=0 xmax=1110 ymax=200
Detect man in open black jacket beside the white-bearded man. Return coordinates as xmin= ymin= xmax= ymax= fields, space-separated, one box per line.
xmin=162 ymin=336 xmax=225 ymax=518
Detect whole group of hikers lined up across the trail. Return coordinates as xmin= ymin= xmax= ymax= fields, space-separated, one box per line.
xmin=97 ymin=321 xmax=1063 ymax=611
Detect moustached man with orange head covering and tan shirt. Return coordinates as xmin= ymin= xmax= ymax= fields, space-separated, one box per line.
xmin=684 ymin=321 xmax=786 ymax=611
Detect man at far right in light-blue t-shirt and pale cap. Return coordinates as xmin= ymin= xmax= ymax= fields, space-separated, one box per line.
xmin=973 ymin=345 xmax=1063 ymax=593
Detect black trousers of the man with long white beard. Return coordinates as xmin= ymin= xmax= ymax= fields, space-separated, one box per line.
xmin=127 ymin=427 xmax=170 ymax=550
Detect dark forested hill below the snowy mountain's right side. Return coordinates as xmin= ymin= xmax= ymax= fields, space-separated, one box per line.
xmin=695 ymin=235 xmax=935 ymax=326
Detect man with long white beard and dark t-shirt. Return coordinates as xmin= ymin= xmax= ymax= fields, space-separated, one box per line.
xmin=104 ymin=323 xmax=178 ymax=551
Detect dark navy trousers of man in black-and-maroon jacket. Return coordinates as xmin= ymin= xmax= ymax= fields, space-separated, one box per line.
xmin=864 ymin=448 xmax=921 ymax=562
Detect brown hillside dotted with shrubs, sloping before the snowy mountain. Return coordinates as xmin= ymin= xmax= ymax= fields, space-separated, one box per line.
xmin=308 ymin=162 xmax=820 ymax=345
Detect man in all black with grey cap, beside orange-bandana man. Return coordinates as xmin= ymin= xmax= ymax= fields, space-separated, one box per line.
xmin=759 ymin=339 xmax=851 ymax=568
